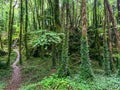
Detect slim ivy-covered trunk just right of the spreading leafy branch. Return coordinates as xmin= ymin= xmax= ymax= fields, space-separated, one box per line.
xmin=58 ymin=0 xmax=70 ymax=77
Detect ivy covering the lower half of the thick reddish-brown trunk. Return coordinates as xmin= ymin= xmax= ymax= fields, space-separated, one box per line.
xmin=80 ymin=37 xmax=93 ymax=80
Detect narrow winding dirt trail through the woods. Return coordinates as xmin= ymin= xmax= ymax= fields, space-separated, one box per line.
xmin=5 ymin=49 xmax=21 ymax=90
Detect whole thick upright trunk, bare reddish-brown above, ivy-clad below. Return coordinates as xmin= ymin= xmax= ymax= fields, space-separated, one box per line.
xmin=80 ymin=0 xmax=93 ymax=79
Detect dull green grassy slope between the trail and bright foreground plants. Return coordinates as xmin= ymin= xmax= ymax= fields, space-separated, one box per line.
xmin=22 ymin=58 xmax=51 ymax=85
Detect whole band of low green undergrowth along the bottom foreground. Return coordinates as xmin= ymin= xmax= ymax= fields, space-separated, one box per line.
xmin=20 ymin=74 xmax=120 ymax=90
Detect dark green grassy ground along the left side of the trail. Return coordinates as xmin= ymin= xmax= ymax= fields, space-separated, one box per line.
xmin=0 ymin=51 xmax=17 ymax=90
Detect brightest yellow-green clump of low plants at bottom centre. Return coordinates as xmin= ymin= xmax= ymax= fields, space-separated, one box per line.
xmin=41 ymin=75 xmax=76 ymax=90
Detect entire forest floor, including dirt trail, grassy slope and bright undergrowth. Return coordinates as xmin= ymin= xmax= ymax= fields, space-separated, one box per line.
xmin=0 ymin=50 xmax=120 ymax=90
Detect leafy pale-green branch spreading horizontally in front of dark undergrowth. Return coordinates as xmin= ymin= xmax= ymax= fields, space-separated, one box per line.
xmin=30 ymin=30 xmax=64 ymax=47
